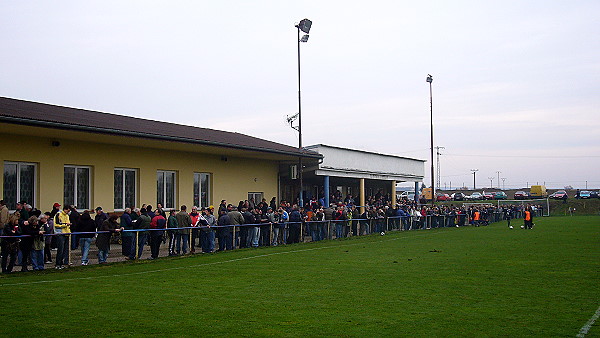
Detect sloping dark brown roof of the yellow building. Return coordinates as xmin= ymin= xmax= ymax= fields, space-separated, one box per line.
xmin=0 ymin=97 xmax=322 ymax=158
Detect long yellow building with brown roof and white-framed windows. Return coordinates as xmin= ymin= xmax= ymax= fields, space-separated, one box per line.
xmin=0 ymin=98 xmax=322 ymax=211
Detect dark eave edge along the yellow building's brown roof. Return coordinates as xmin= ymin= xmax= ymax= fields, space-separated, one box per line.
xmin=0 ymin=115 xmax=323 ymax=159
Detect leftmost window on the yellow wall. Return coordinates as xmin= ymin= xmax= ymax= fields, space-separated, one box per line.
xmin=3 ymin=161 xmax=37 ymax=210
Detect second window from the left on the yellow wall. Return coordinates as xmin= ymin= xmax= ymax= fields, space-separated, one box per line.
xmin=63 ymin=165 xmax=91 ymax=209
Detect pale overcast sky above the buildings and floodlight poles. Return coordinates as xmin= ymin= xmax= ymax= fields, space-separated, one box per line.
xmin=0 ymin=0 xmax=600 ymax=188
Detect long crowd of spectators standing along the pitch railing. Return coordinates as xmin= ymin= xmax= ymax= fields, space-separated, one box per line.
xmin=0 ymin=192 xmax=541 ymax=273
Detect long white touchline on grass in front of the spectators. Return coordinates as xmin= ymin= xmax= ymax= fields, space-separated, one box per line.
xmin=0 ymin=231 xmax=447 ymax=287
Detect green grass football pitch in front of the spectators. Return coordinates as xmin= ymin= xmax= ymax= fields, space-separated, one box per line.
xmin=0 ymin=216 xmax=600 ymax=337
